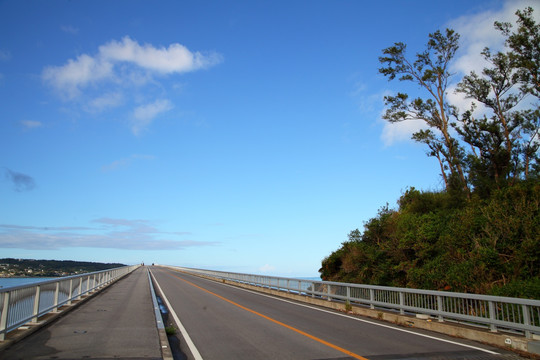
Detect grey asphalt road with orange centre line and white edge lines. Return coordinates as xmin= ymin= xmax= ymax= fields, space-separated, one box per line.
xmin=151 ymin=267 xmax=518 ymax=360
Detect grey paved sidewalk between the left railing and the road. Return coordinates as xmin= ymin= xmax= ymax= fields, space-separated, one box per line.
xmin=0 ymin=267 xmax=162 ymax=360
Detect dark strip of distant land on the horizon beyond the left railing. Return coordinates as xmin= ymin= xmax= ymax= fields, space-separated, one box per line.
xmin=0 ymin=258 xmax=125 ymax=278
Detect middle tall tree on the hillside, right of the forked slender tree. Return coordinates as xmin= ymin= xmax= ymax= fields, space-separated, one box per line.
xmin=455 ymin=48 xmax=524 ymax=193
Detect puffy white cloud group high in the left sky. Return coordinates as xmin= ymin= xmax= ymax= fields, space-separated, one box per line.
xmin=41 ymin=36 xmax=222 ymax=135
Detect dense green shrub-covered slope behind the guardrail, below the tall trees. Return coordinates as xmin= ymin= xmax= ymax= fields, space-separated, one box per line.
xmin=319 ymin=181 xmax=540 ymax=299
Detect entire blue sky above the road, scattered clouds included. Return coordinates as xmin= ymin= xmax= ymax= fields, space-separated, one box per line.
xmin=0 ymin=0 xmax=540 ymax=276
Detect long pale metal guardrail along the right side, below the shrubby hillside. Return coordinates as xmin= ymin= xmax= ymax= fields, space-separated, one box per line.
xmin=170 ymin=266 xmax=540 ymax=338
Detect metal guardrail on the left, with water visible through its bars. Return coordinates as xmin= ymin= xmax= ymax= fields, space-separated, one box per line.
xmin=0 ymin=265 xmax=140 ymax=341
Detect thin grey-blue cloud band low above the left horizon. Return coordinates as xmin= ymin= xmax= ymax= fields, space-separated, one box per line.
xmin=0 ymin=218 xmax=215 ymax=250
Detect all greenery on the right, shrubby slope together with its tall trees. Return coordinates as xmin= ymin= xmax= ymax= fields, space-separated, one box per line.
xmin=319 ymin=8 xmax=540 ymax=299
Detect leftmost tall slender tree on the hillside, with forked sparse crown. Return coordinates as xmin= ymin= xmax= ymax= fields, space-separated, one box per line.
xmin=379 ymin=29 xmax=469 ymax=194
